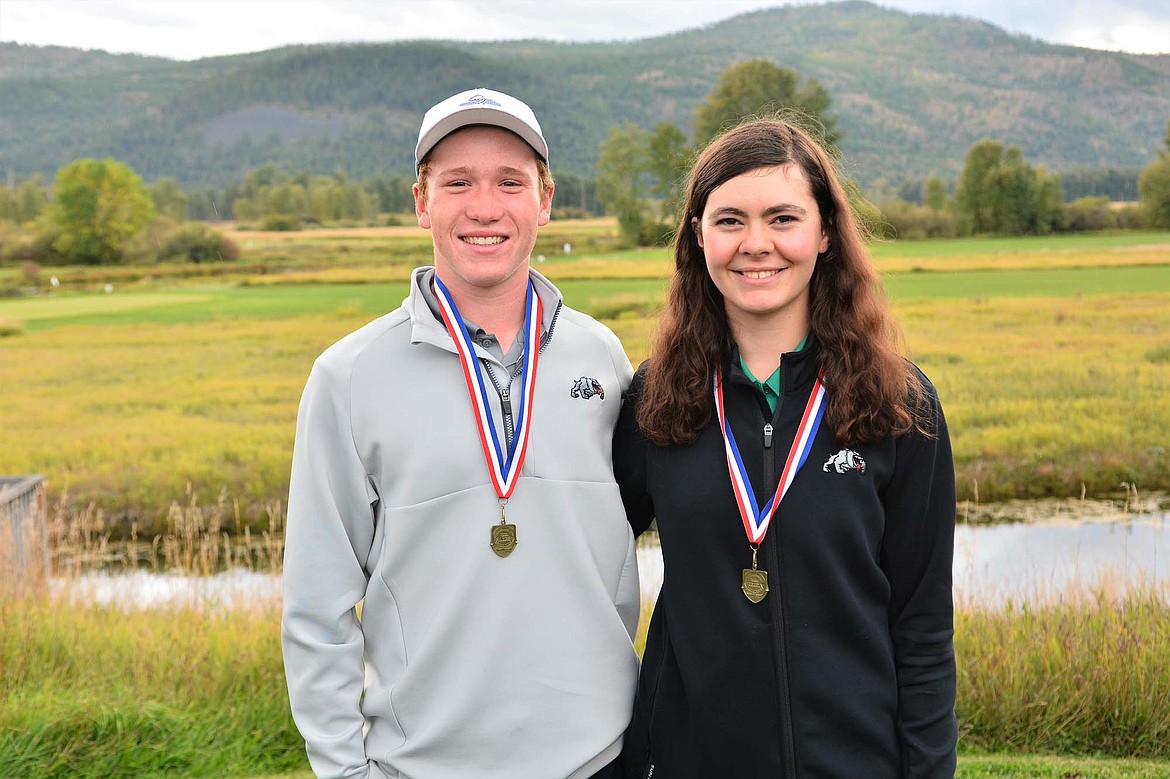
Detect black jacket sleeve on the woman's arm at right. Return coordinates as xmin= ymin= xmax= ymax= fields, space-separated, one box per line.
xmin=881 ymin=374 xmax=958 ymax=779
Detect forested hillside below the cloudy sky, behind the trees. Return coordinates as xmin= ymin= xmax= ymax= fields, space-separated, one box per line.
xmin=0 ymin=1 xmax=1170 ymax=188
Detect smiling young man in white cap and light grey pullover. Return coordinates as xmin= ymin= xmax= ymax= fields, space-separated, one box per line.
xmin=282 ymin=89 xmax=639 ymax=779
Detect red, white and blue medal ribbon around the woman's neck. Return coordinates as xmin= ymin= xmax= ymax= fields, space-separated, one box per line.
xmin=715 ymin=368 xmax=825 ymax=544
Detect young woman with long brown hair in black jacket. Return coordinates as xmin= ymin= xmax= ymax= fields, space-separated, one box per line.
xmin=614 ymin=119 xmax=957 ymax=779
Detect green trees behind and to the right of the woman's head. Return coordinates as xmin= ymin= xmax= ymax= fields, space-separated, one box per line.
xmin=597 ymin=60 xmax=1170 ymax=244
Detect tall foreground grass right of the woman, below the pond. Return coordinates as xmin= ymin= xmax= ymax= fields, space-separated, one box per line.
xmin=955 ymin=585 xmax=1170 ymax=759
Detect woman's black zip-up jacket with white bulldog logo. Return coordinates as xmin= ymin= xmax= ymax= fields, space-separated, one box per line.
xmin=614 ymin=344 xmax=957 ymax=779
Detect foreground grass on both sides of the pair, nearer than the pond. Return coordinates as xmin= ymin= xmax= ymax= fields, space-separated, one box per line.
xmin=0 ymin=582 xmax=1170 ymax=779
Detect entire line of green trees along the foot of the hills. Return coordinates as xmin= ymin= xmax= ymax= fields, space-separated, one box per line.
xmin=0 ymin=60 xmax=1170 ymax=264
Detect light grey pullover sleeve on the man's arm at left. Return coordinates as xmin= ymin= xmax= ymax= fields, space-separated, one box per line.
xmin=281 ymin=359 xmax=376 ymax=778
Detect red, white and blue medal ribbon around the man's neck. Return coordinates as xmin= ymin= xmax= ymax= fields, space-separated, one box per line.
xmin=435 ymin=276 xmax=543 ymax=501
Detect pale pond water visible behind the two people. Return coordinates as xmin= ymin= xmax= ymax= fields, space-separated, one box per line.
xmin=51 ymin=504 xmax=1170 ymax=608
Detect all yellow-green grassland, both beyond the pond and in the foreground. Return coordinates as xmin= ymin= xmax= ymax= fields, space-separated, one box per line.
xmin=0 ymin=223 xmax=1170 ymax=779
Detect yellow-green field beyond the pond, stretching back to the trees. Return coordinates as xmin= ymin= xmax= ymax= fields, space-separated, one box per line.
xmin=0 ymin=223 xmax=1170 ymax=532
